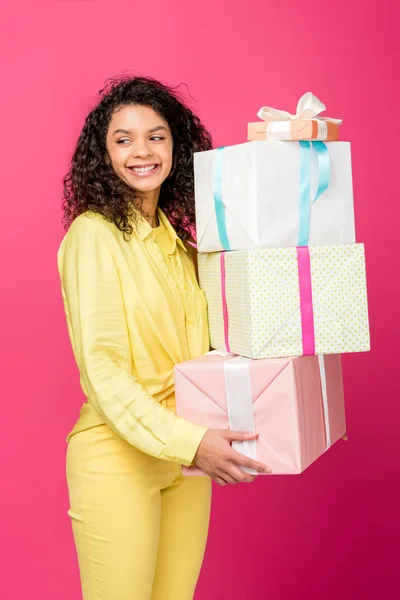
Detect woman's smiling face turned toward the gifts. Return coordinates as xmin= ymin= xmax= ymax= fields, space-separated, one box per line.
xmin=106 ymin=104 xmax=173 ymax=199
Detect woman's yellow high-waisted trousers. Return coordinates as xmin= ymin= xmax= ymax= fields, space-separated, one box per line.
xmin=67 ymin=425 xmax=211 ymax=600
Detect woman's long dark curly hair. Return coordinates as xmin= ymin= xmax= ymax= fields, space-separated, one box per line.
xmin=63 ymin=76 xmax=212 ymax=239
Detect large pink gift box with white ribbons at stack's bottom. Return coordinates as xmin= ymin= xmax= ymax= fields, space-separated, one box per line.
xmin=175 ymin=353 xmax=346 ymax=475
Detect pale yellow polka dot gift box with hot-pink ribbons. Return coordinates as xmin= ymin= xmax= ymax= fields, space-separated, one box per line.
xmin=198 ymin=244 xmax=370 ymax=359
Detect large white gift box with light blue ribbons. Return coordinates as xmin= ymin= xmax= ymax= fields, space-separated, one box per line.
xmin=194 ymin=141 xmax=355 ymax=253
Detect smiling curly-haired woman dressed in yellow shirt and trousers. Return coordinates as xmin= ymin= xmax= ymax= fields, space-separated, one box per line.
xmin=58 ymin=78 xmax=268 ymax=600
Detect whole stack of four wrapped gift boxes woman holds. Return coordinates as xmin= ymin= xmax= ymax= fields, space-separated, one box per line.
xmin=175 ymin=93 xmax=369 ymax=475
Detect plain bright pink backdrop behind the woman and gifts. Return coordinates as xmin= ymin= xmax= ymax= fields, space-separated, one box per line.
xmin=0 ymin=0 xmax=400 ymax=600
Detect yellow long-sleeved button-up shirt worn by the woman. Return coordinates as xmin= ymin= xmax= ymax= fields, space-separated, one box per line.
xmin=58 ymin=210 xmax=209 ymax=465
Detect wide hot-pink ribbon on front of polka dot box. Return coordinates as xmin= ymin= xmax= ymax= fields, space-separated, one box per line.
xmin=297 ymin=246 xmax=315 ymax=356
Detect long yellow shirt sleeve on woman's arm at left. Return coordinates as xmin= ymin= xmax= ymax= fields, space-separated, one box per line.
xmin=58 ymin=218 xmax=206 ymax=465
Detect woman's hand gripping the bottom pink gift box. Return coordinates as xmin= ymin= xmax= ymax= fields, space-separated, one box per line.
xmin=194 ymin=429 xmax=271 ymax=485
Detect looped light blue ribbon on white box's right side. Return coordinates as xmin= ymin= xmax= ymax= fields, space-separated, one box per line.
xmin=297 ymin=141 xmax=331 ymax=246
